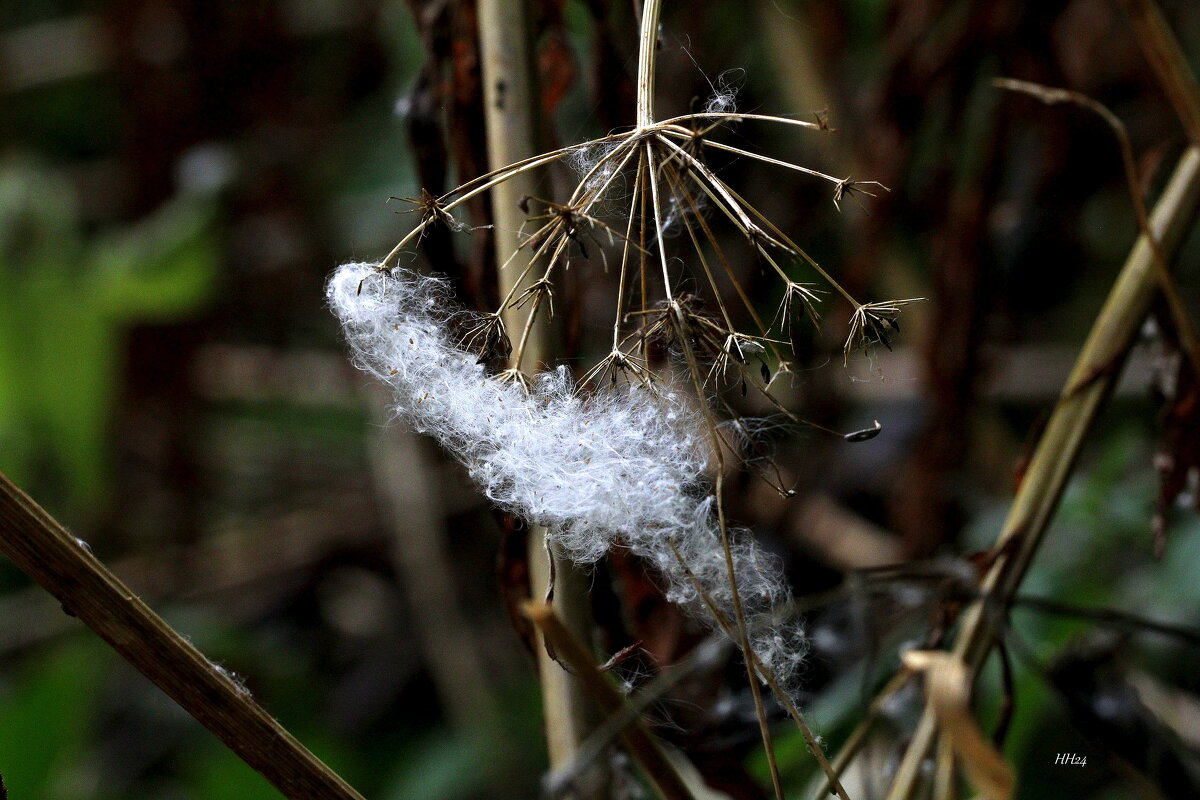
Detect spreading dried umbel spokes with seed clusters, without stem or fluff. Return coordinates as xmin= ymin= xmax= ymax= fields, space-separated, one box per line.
xmin=379 ymin=107 xmax=916 ymax=381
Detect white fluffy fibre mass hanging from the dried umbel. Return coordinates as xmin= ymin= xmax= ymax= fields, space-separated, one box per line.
xmin=326 ymin=264 xmax=802 ymax=682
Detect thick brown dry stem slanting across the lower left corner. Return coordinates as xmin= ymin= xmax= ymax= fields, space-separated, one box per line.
xmin=0 ymin=474 xmax=364 ymax=800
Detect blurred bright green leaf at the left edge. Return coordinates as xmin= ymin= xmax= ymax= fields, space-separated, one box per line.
xmin=0 ymin=157 xmax=218 ymax=518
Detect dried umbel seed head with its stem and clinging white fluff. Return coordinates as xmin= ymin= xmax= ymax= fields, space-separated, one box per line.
xmin=329 ymin=0 xmax=913 ymax=794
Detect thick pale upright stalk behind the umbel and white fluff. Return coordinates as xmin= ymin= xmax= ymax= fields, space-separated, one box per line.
xmin=479 ymin=0 xmax=604 ymax=796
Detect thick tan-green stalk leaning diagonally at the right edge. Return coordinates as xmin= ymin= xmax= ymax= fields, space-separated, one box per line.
xmin=888 ymin=146 xmax=1200 ymax=800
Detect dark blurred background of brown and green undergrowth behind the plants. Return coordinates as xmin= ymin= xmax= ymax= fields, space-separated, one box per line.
xmin=0 ymin=0 xmax=1200 ymax=800
